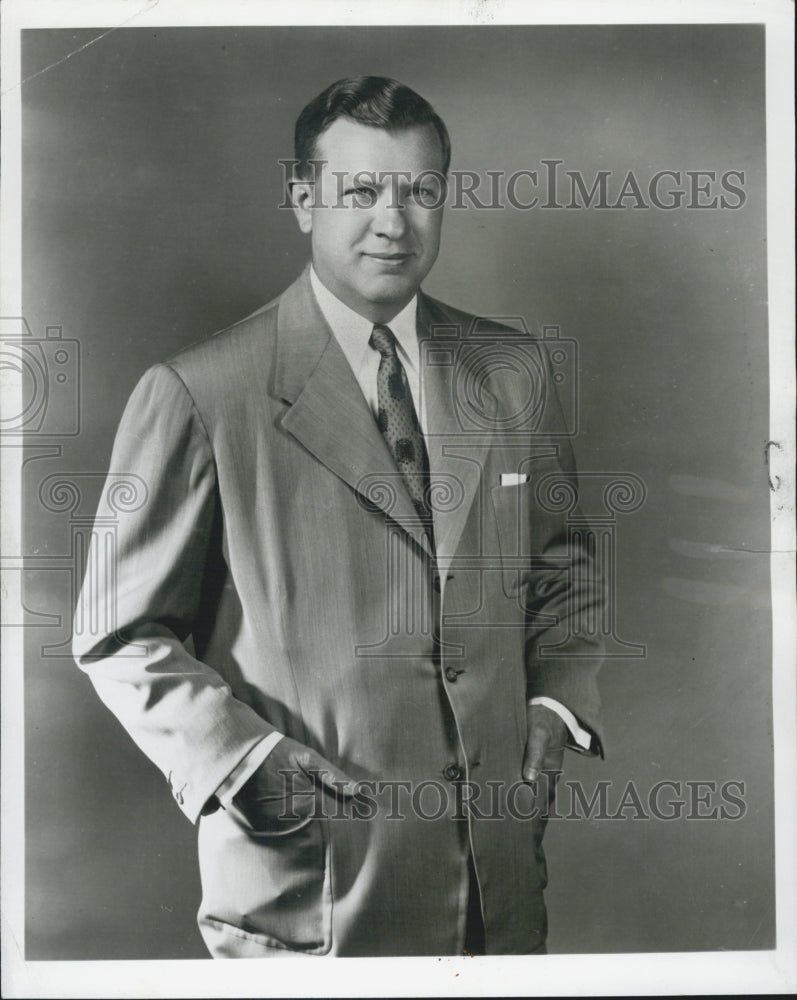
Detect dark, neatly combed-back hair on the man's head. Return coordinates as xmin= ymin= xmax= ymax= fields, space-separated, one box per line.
xmin=294 ymin=76 xmax=451 ymax=178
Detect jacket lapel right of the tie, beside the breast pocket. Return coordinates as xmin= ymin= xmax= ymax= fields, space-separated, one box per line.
xmin=418 ymin=295 xmax=497 ymax=586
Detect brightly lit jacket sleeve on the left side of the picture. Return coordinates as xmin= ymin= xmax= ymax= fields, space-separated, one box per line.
xmin=73 ymin=365 xmax=274 ymax=822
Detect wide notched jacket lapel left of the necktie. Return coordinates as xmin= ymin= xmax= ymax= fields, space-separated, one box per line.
xmin=273 ymin=267 xmax=430 ymax=552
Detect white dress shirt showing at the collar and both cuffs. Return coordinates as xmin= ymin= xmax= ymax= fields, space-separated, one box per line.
xmin=216 ymin=266 xmax=592 ymax=807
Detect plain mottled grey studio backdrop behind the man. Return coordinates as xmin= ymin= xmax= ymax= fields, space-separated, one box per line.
xmin=21 ymin=25 xmax=774 ymax=959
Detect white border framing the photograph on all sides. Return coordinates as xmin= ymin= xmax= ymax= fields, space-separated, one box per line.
xmin=0 ymin=0 xmax=797 ymax=998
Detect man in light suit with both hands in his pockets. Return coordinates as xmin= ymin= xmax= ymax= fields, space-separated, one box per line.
xmin=75 ymin=77 xmax=600 ymax=957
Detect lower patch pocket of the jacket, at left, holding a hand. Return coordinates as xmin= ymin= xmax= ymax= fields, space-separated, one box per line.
xmin=199 ymin=809 xmax=332 ymax=955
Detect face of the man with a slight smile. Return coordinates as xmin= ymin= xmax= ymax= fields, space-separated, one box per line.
xmin=294 ymin=118 xmax=443 ymax=323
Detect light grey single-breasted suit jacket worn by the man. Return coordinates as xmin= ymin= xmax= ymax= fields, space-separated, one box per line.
xmin=74 ymin=271 xmax=601 ymax=956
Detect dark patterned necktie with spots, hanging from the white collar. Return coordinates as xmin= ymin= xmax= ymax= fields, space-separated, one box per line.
xmin=369 ymin=323 xmax=432 ymax=540
